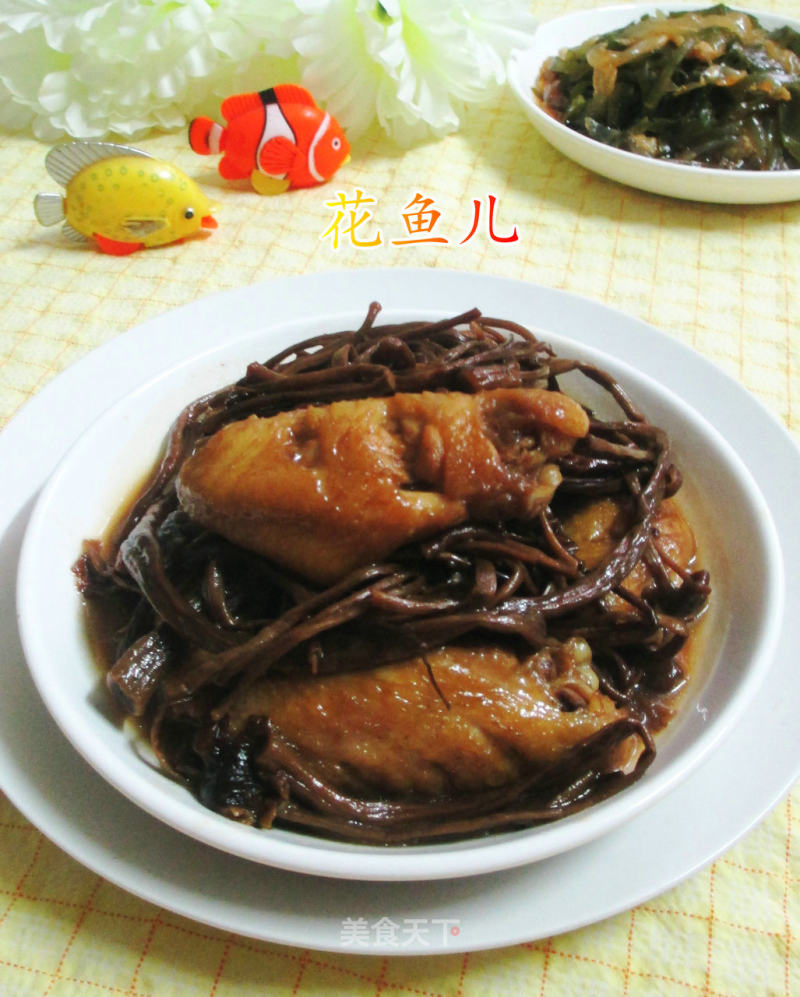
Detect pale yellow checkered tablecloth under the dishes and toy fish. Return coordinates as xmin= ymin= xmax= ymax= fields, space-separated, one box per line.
xmin=0 ymin=0 xmax=800 ymax=997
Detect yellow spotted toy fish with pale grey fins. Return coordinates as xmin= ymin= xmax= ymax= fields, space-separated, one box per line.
xmin=33 ymin=142 xmax=217 ymax=256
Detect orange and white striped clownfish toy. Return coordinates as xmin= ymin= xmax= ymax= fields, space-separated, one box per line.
xmin=189 ymin=83 xmax=350 ymax=194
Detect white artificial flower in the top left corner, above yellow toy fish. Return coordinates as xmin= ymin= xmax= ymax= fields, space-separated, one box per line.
xmin=0 ymin=0 xmax=304 ymax=140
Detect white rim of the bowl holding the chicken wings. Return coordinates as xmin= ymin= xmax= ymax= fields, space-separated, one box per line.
xmin=18 ymin=308 xmax=783 ymax=881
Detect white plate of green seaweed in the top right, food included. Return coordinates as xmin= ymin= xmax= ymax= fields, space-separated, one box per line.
xmin=509 ymin=3 xmax=800 ymax=204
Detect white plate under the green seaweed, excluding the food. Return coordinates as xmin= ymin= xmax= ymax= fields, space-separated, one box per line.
xmin=508 ymin=3 xmax=800 ymax=204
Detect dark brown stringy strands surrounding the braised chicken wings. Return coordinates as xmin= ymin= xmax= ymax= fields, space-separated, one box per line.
xmin=75 ymin=304 xmax=709 ymax=843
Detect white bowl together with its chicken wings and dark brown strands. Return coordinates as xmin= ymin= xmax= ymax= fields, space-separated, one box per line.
xmin=15 ymin=305 xmax=780 ymax=879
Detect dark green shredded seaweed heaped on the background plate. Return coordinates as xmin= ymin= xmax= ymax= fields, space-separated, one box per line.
xmin=535 ymin=4 xmax=800 ymax=170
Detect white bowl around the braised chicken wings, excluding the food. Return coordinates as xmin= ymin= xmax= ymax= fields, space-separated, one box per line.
xmin=18 ymin=301 xmax=783 ymax=880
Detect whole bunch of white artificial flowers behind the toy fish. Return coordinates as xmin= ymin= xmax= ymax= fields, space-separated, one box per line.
xmin=0 ymin=0 xmax=534 ymax=144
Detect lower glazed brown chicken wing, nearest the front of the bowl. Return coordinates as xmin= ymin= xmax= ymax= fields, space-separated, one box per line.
xmin=229 ymin=640 xmax=639 ymax=799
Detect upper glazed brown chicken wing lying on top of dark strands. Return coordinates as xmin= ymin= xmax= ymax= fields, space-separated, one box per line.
xmin=178 ymin=388 xmax=589 ymax=585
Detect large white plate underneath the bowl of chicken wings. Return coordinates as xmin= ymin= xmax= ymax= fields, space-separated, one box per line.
xmin=0 ymin=269 xmax=800 ymax=954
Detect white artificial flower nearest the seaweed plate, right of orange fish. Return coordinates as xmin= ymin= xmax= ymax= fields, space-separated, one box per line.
xmin=294 ymin=0 xmax=535 ymax=145
